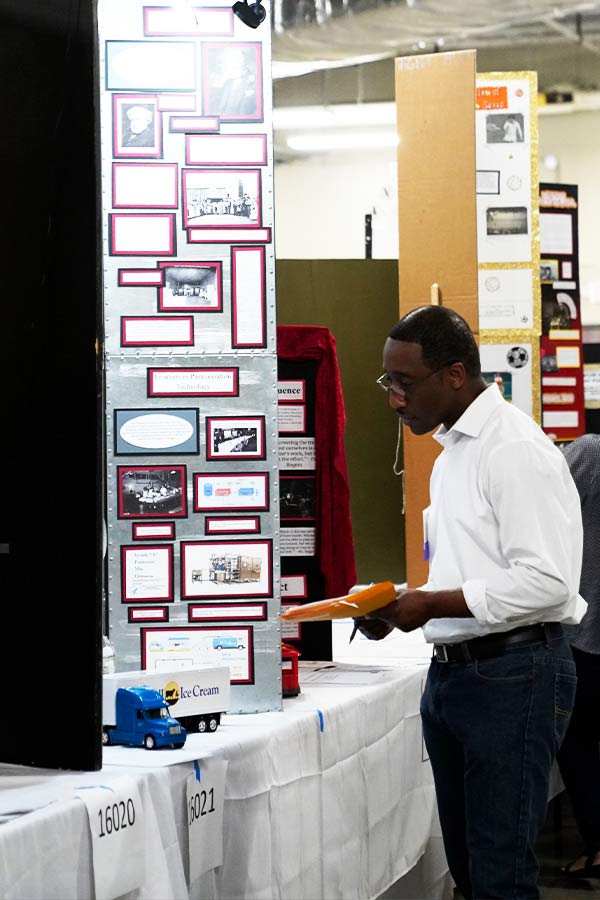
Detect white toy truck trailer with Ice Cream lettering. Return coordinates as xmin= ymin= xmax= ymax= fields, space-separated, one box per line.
xmin=102 ymin=666 xmax=230 ymax=743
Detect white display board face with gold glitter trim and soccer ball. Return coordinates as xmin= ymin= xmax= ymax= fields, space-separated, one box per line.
xmin=475 ymin=72 xmax=541 ymax=424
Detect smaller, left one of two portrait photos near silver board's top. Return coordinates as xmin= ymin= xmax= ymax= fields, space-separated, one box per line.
xmin=113 ymin=94 xmax=162 ymax=159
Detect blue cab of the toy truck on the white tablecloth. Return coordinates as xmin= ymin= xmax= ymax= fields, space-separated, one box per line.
xmin=103 ymin=687 xmax=187 ymax=750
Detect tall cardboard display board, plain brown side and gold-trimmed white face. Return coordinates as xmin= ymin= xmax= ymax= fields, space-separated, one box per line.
xmin=396 ymin=51 xmax=541 ymax=587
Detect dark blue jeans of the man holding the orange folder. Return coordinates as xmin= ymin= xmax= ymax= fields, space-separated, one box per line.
xmin=421 ymin=637 xmax=577 ymax=900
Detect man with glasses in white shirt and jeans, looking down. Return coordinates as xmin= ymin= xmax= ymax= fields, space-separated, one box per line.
xmin=357 ymin=306 xmax=586 ymax=900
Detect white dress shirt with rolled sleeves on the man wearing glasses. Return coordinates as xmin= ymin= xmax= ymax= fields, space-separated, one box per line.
xmin=423 ymin=384 xmax=587 ymax=643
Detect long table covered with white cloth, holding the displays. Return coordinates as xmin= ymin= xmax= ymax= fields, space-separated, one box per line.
xmin=0 ymin=659 xmax=451 ymax=900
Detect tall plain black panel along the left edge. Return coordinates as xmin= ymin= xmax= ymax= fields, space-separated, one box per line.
xmin=0 ymin=0 xmax=103 ymax=770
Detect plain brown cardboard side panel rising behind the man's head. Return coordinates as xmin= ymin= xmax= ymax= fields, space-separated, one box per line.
xmin=395 ymin=50 xmax=479 ymax=587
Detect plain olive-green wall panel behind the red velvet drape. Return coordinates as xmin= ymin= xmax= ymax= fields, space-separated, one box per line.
xmin=275 ymin=259 xmax=405 ymax=584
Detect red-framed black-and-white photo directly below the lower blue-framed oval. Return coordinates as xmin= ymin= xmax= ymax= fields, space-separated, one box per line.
xmin=117 ymin=466 xmax=187 ymax=519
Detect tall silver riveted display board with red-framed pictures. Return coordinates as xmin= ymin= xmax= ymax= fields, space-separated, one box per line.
xmin=97 ymin=0 xmax=281 ymax=713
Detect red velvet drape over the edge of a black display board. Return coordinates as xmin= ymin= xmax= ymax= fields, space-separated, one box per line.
xmin=277 ymin=325 xmax=356 ymax=598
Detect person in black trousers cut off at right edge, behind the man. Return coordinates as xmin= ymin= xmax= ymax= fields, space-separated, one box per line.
xmin=558 ymin=434 xmax=600 ymax=878
